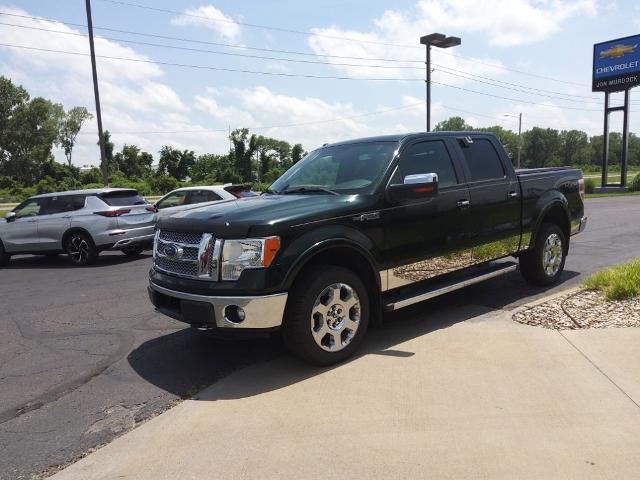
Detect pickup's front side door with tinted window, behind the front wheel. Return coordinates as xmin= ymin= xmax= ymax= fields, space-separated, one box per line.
xmin=382 ymin=139 xmax=469 ymax=289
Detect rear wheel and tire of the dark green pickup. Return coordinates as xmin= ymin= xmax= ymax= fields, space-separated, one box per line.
xmin=520 ymin=223 xmax=567 ymax=286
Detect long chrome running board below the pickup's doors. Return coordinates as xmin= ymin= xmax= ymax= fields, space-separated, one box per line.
xmin=383 ymin=262 xmax=518 ymax=312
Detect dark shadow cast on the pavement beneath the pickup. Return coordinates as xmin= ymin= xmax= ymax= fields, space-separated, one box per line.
xmin=128 ymin=271 xmax=579 ymax=400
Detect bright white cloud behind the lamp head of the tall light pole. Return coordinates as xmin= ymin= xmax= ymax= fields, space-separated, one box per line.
xmin=308 ymin=0 xmax=596 ymax=84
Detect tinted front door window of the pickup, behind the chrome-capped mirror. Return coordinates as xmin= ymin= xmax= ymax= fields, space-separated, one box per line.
xmin=393 ymin=140 xmax=458 ymax=188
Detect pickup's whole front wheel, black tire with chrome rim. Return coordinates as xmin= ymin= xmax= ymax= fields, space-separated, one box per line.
xmin=282 ymin=266 xmax=371 ymax=366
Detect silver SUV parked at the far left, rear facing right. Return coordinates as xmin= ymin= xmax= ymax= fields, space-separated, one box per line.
xmin=0 ymin=188 xmax=157 ymax=266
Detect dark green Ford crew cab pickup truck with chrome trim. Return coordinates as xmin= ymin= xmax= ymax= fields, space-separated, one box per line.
xmin=149 ymin=132 xmax=587 ymax=365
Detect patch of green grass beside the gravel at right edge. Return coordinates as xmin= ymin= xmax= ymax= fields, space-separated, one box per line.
xmin=583 ymin=258 xmax=640 ymax=300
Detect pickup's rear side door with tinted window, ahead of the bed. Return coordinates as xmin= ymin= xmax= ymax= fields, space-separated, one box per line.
xmin=458 ymin=137 xmax=521 ymax=263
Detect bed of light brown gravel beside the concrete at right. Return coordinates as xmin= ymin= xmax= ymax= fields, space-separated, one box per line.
xmin=513 ymin=290 xmax=640 ymax=330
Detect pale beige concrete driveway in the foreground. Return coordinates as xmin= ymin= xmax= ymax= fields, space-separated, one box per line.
xmin=54 ymin=301 xmax=640 ymax=480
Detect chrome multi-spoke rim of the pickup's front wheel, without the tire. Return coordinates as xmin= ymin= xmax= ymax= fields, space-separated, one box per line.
xmin=311 ymin=283 xmax=361 ymax=352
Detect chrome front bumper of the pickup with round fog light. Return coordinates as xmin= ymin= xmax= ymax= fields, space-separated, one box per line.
xmin=149 ymin=282 xmax=287 ymax=330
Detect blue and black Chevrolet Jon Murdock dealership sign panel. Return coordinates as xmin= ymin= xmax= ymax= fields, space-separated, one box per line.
xmin=592 ymin=35 xmax=640 ymax=92
